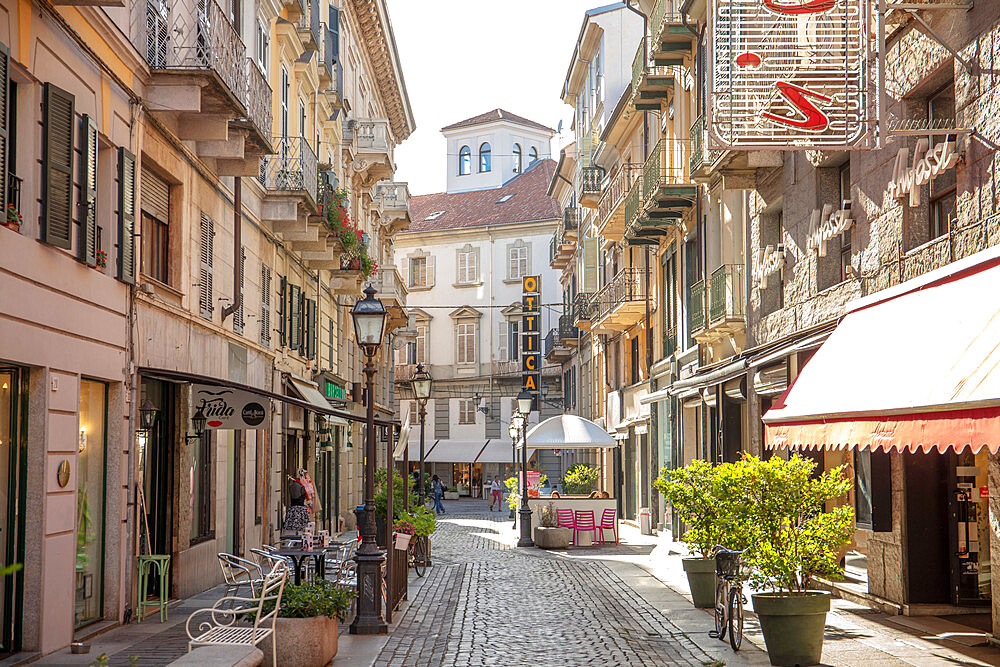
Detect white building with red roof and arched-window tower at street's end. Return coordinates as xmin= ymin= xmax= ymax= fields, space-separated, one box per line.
xmin=394 ymin=109 xmax=563 ymax=497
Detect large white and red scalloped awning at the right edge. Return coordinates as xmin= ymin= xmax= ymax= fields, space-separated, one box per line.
xmin=764 ymin=250 xmax=1000 ymax=452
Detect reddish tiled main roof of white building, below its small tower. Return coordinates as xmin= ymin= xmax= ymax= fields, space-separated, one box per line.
xmin=403 ymin=160 xmax=561 ymax=235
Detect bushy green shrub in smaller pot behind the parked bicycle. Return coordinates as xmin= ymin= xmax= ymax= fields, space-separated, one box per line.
xmin=653 ymin=459 xmax=745 ymax=609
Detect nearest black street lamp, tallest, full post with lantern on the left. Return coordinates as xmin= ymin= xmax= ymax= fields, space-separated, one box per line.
xmin=351 ymin=285 xmax=392 ymax=635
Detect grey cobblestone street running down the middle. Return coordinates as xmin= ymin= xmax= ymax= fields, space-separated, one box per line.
xmin=376 ymin=512 xmax=714 ymax=666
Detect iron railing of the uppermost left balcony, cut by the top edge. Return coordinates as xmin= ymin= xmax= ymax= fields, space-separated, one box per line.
xmin=140 ymin=0 xmax=246 ymax=103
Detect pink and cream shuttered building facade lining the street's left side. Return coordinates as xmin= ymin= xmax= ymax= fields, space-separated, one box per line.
xmin=0 ymin=0 xmax=414 ymax=654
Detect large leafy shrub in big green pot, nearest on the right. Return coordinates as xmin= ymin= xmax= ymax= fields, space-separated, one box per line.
xmin=740 ymin=455 xmax=854 ymax=665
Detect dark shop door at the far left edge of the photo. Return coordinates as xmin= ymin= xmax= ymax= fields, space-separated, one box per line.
xmin=0 ymin=368 xmax=27 ymax=657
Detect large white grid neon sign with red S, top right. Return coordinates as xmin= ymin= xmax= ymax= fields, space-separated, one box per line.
xmin=709 ymin=0 xmax=881 ymax=150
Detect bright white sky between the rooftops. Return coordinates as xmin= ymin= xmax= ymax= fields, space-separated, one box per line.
xmin=387 ymin=0 xmax=611 ymax=195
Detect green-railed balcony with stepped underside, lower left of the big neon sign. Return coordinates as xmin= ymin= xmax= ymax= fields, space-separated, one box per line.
xmin=625 ymin=139 xmax=698 ymax=245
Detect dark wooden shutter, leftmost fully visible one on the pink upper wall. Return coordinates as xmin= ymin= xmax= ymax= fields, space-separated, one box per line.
xmin=42 ymin=83 xmax=75 ymax=250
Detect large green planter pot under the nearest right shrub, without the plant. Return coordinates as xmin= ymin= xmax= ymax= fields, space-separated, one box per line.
xmin=751 ymin=591 xmax=830 ymax=667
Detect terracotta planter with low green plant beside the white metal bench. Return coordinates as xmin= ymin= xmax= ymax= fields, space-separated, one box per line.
xmin=260 ymin=579 xmax=354 ymax=667
